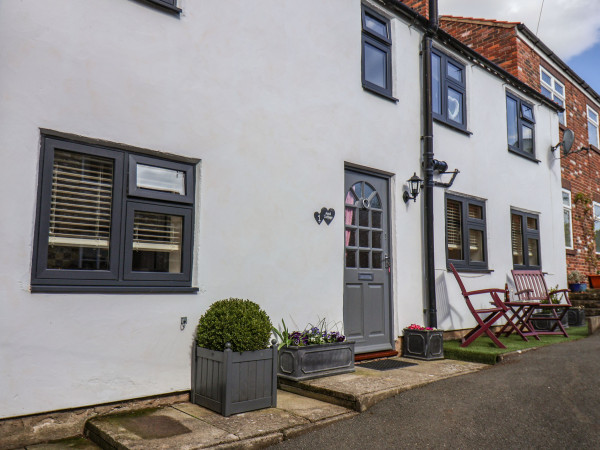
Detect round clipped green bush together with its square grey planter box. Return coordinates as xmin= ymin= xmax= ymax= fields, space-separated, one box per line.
xmin=192 ymin=298 xmax=277 ymax=416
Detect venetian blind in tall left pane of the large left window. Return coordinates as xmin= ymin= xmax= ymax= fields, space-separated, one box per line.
xmin=48 ymin=150 xmax=113 ymax=248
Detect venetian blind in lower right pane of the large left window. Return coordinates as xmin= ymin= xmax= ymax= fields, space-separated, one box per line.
xmin=133 ymin=211 xmax=183 ymax=252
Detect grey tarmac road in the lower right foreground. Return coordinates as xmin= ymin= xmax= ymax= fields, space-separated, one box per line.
xmin=274 ymin=334 xmax=600 ymax=450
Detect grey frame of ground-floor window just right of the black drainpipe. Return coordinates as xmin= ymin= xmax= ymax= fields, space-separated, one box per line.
xmin=444 ymin=194 xmax=488 ymax=271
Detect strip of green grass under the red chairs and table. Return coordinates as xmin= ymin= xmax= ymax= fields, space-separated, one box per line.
xmin=444 ymin=326 xmax=588 ymax=364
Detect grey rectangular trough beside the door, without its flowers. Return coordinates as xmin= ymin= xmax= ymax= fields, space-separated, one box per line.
xmin=277 ymin=342 xmax=354 ymax=381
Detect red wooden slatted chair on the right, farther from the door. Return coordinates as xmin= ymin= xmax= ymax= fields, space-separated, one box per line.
xmin=512 ymin=270 xmax=571 ymax=337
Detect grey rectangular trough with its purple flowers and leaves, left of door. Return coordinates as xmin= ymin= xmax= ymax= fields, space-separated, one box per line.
xmin=273 ymin=319 xmax=354 ymax=381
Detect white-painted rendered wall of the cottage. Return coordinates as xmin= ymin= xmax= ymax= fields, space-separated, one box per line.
xmin=0 ymin=0 xmax=565 ymax=418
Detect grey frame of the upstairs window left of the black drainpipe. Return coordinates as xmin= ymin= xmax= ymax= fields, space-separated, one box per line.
xmin=361 ymin=5 xmax=398 ymax=101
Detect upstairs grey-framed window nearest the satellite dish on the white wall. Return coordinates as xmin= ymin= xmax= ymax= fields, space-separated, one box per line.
xmin=506 ymin=93 xmax=535 ymax=159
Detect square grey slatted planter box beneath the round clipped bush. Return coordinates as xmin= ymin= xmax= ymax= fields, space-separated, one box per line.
xmin=192 ymin=346 xmax=277 ymax=416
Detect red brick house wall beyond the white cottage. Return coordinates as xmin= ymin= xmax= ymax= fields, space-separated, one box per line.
xmin=403 ymin=0 xmax=600 ymax=274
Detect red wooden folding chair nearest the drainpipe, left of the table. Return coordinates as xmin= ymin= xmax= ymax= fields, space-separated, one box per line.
xmin=450 ymin=264 xmax=514 ymax=348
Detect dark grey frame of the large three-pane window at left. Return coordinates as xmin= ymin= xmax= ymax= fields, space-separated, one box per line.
xmin=31 ymin=134 xmax=197 ymax=292
